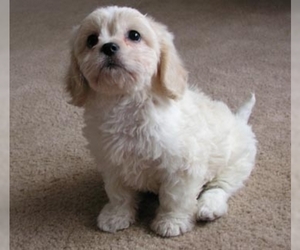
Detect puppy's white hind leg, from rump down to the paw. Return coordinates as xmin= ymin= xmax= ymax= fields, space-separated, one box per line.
xmin=196 ymin=154 xmax=255 ymax=221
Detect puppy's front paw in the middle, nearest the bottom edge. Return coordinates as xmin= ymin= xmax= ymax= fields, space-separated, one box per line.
xmin=151 ymin=214 xmax=195 ymax=237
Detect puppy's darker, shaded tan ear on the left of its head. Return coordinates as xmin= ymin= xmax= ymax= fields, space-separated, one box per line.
xmin=66 ymin=52 xmax=90 ymax=107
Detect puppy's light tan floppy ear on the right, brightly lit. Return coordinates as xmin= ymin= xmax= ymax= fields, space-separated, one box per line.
xmin=150 ymin=20 xmax=188 ymax=99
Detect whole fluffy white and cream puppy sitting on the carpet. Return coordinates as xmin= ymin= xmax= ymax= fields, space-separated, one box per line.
xmin=66 ymin=6 xmax=256 ymax=237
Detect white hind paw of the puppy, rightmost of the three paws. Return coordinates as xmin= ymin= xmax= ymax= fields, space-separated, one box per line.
xmin=196 ymin=190 xmax=228 ymax=221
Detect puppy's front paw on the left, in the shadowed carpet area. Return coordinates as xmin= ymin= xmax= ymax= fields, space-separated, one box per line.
xmin=97 ymin=203 xmax=135 ymax=233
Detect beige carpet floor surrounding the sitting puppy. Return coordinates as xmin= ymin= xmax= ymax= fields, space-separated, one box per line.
xmin=10 ymin=0 xmax=291 ymax=250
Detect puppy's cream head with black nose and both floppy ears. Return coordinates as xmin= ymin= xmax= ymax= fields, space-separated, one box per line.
xmin=67 ymin=6 xmax=187 ymax=106
